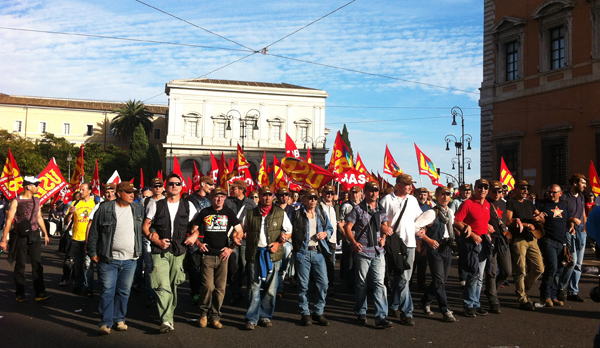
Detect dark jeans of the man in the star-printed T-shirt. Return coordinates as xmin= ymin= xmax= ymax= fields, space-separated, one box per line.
xmin=538 ymin=238 xmax=563 ymax=300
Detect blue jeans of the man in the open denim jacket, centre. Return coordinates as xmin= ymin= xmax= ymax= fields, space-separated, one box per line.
xmin=295 ymin=250 xmax=328 ymax=315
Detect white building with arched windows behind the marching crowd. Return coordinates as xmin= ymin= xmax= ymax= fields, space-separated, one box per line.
xmin=163 ymin=79 xmax=329 ymax=176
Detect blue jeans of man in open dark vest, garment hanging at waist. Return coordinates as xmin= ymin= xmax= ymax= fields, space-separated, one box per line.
xmin=246 ymin=257 xmax=281 ymax=324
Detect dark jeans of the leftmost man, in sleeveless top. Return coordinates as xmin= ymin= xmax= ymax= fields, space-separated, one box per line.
xmin=11 ymin=232 xmax=46 ymax=297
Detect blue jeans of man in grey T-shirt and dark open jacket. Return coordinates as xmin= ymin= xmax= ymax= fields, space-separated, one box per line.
xmin=98 ymin=260 xmax=137 ymax=327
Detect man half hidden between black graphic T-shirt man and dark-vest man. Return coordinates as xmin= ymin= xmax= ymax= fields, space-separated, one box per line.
xmin=225 ymin=180 xmax=256 ymax=304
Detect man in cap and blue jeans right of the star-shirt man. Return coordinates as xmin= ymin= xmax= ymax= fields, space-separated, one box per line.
xmin=558 ymin=173 xmax=587 ymax=302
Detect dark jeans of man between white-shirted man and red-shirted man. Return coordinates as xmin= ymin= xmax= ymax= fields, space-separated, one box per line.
xmin=421 ymin=247 xmax=452 ymax=313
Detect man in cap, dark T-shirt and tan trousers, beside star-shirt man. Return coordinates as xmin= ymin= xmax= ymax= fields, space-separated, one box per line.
xmin=506 ymin=180 xmax=544 ymax=311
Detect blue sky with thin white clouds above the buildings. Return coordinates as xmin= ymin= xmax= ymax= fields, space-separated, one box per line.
xmin=0 ymin=0 xmax=483 ymax=188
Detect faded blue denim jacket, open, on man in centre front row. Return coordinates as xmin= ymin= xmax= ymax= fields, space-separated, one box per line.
xmin=292 ymin=205 xmax=333 ymax=254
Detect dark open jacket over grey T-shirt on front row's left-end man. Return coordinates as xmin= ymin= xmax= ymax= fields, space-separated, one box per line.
xmin=88 ymin=201 xmax=144 ymax=262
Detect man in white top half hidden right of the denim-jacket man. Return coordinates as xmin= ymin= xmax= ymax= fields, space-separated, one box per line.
xmin=319 ymin=185 xmax=344 ymax=296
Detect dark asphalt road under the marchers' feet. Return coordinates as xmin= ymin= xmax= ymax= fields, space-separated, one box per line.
xmin=0 ymin=237 xmax=600 ymax=348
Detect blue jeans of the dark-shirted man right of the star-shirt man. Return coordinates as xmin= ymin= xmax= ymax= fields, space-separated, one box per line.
xmin=558 ymin=223 xmax=587 ymax=295
